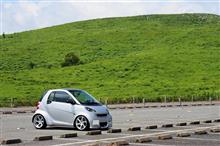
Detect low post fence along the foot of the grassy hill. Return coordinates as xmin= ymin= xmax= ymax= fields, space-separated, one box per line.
xmin=0 ymin=96 xmax=220 ymax=107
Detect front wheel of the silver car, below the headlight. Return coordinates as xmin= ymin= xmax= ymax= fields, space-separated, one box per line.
xmin=75 ymin=116 xmax=89 ymax=131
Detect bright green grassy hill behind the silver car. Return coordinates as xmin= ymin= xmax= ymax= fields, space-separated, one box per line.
xmin=0 ymin=14 xmax=220 ymax=106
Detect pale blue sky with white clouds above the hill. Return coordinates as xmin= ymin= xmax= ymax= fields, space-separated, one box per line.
xmin=0 ymin=0 xmax=220 ymax=34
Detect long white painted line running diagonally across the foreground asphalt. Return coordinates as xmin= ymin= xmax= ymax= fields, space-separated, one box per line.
xmin=52 ymin=125 xmax=219 ymax=146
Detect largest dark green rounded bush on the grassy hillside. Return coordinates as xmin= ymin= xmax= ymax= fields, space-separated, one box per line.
xmin=61 ymin=52 xmax=80 ymax=67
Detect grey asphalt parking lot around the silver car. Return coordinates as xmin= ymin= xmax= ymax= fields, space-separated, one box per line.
xmin=0 ymin=105 xmax=220 ymax=146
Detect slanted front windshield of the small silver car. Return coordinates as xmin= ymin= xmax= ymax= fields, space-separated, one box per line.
xmin=68 ymin=90 xmax=100 ymax=105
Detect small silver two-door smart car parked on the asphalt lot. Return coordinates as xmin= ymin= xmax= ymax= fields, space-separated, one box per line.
xmin=32 ymin=89 xmax=112 ymax=130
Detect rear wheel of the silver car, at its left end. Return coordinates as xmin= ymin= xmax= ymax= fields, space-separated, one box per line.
xmin=33 ymin=114 xmax=47 ymax=129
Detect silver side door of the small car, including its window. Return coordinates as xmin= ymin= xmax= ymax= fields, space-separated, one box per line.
xmin=47 ymin=91 xmax=74 ymax=125
